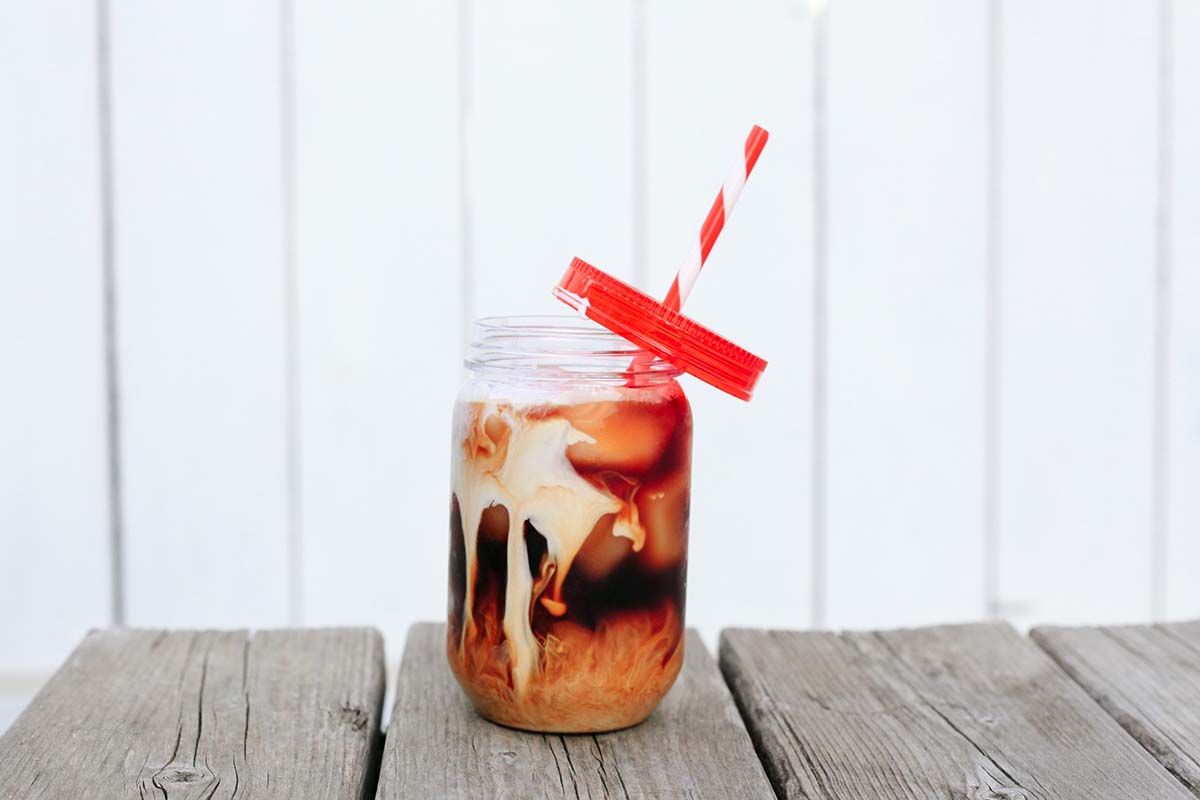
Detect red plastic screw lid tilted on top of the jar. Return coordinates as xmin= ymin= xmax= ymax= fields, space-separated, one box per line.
xmin=554 ymin=258 xmax=767 ymax=401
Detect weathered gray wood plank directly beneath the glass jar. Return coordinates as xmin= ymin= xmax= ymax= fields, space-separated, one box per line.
xmin=378 ymin=624 xmax=775 ymax=800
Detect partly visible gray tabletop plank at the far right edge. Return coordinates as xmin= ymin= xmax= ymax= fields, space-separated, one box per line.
xmin=1030 ymin=621 xmax=1200 ymax=796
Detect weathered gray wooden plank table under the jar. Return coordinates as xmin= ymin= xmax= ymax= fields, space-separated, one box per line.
xmin=0 ymin=622 xmax=1200 ymax=800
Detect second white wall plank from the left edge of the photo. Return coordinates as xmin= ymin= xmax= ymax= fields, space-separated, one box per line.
xmin=112 ymin=0 xmax=288 ymax=626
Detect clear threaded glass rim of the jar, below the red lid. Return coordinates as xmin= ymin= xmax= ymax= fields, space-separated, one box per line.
xmin=463 ymin=314 xmax=683 ymax=385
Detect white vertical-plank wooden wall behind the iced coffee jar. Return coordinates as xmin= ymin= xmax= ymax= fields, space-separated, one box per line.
xmin=0 ymin=0 xmax=1200 ymax=728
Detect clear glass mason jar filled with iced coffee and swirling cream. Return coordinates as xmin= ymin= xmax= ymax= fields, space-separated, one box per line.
xmin=446 ymin=317 xmax=691 ymax=733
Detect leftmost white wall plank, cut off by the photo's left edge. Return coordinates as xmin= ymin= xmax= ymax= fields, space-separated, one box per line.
xmin=0 ymin=1 xmax=112 ymax=671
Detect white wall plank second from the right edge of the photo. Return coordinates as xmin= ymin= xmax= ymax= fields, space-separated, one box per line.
xmin=998 ymin=0 xmax=1158 ymax=622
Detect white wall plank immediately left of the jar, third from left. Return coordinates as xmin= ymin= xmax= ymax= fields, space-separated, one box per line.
xmin=294 ymin=0 xmax=462 ymax=657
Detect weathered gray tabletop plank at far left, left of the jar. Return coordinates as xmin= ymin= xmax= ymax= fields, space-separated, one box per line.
xmin=0 ymin=628 xmax=384 ymax=800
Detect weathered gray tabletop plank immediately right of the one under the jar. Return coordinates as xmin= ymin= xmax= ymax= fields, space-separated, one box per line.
xmin=720 ymin=624 xmax=1190 ymax=800
